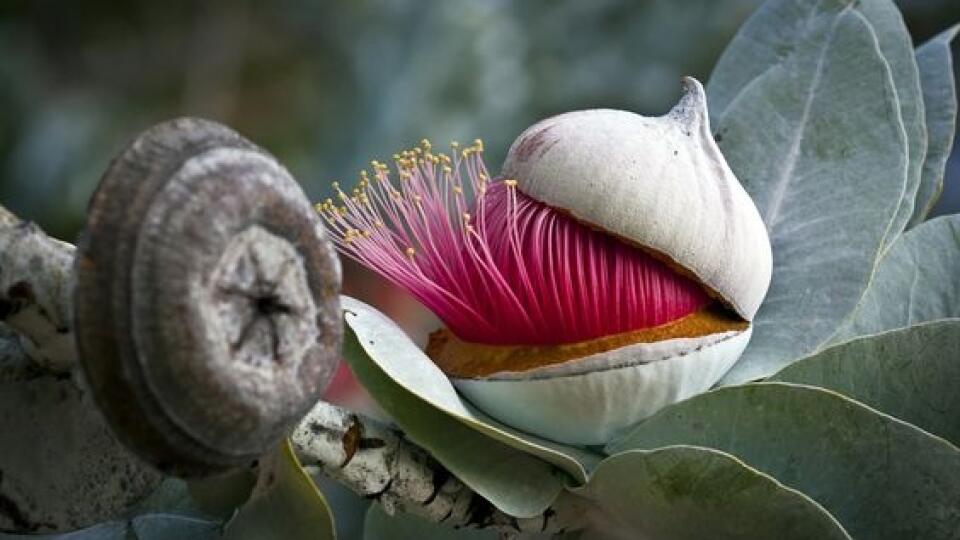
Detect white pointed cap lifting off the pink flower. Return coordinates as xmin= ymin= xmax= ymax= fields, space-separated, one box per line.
xmin=502 ymin=77 xmax=773 ymax=321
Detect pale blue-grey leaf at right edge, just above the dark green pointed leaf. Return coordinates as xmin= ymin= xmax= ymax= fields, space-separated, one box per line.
xmin=831 ymin=214 xmax=960 ymax=343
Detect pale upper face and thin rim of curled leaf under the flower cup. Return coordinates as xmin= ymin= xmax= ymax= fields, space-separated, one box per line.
xmin=341 ymin=296 xmax=600 ymax=478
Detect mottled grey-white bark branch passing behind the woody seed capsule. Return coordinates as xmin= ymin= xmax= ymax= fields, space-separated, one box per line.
xmin=0 ymin=206 xmax=584 ymax=538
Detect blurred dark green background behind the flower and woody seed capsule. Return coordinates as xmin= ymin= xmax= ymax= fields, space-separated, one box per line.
xmin=0 ymin=0 xmax=960 ymax=266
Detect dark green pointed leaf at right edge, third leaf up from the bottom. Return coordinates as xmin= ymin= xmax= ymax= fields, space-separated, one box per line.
xmin=773 ymin=319 xmax=960 ymax=445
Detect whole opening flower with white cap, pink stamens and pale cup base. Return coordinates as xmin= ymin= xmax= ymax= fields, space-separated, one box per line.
xmin=318 ymin=77 xmax=772 ymax=445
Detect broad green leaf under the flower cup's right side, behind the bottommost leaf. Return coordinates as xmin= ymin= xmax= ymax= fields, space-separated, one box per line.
xmin=609 ymin=383 xmax=960 ymax=540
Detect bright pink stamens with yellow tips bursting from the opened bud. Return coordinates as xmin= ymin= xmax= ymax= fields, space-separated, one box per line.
xmin=317 ymin=141 xmax=708 ymax=345
